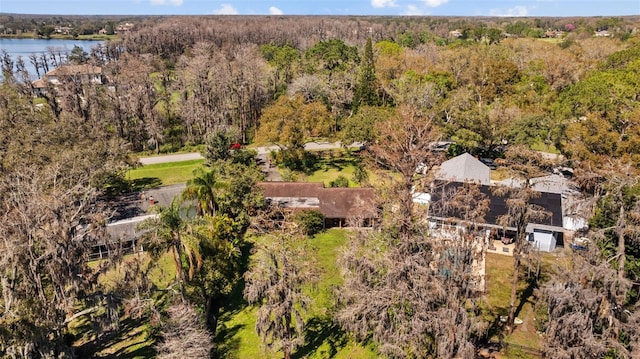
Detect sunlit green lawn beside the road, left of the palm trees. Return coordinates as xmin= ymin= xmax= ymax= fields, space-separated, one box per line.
xmin=127 ymin=160 xmax=204 ymax=189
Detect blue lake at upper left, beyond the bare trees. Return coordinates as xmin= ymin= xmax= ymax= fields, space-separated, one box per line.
xmin=0 ymin=38 xmax=104 ymax=80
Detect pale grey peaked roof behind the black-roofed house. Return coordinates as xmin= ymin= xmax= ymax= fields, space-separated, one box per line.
xmin=437 ymin=152 xmax=490 ymax=186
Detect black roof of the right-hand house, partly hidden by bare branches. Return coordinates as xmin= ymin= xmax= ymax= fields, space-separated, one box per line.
xmin=431 ymin=182 xmax=562 ymax=228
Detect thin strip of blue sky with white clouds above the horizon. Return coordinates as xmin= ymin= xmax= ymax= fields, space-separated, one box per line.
xmin=0 ymin=0 xmax=640 ymax=17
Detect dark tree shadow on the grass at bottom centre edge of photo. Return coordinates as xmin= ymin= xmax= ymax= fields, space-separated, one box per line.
xmin=291 ymin=317 xmax=347 ymax=359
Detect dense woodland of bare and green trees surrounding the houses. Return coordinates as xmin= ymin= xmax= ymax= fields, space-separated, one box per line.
xmin=0 ymin=15 xmax=640 ymax=358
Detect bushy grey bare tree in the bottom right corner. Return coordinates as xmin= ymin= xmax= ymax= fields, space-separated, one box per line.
xmin=541 ymin=248 xmax=640 ymax=358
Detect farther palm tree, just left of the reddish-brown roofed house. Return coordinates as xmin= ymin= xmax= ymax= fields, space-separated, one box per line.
xmin=182 ymin=168 xmax=225 ymax=216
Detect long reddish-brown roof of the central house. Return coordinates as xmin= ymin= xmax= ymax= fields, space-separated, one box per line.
xmin=260 ymin=182 xmax=377 ymax=218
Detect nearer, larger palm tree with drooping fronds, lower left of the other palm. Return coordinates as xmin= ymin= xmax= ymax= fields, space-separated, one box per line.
xmin=141 ymin=198 xmax=202 ymax=301
